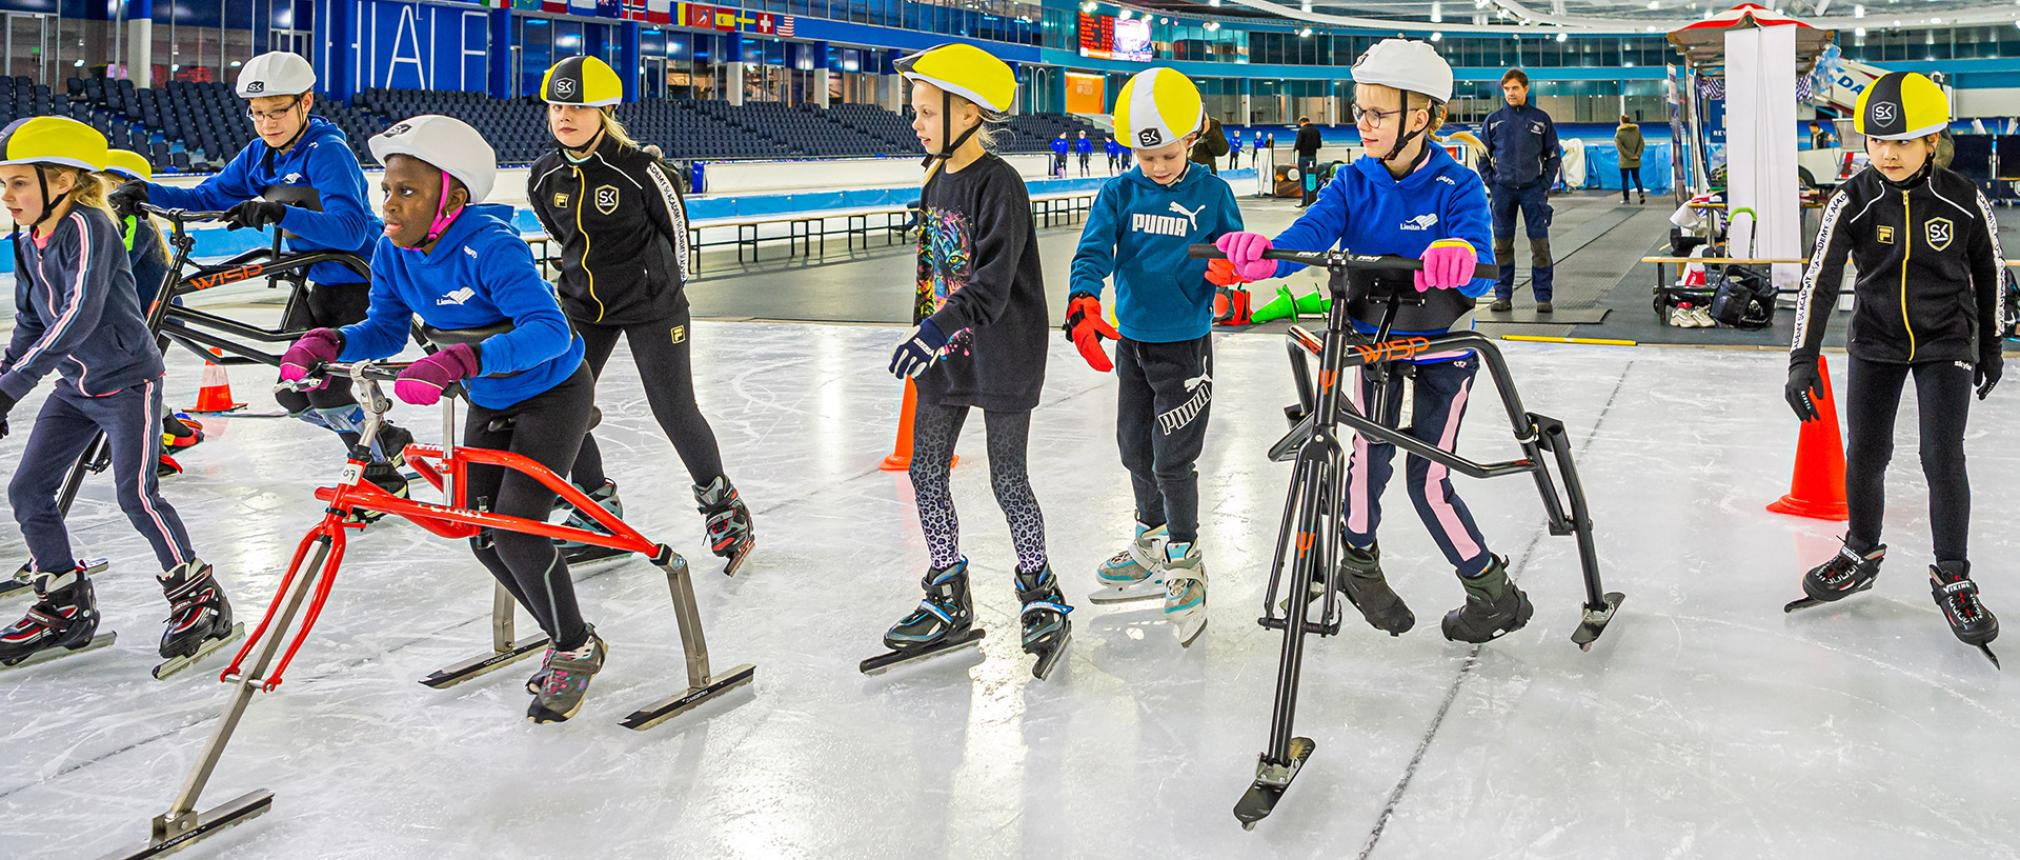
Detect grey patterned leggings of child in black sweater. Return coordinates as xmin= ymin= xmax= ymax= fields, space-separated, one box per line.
xmin=911 ymin=402 xmax=1046 ymax=571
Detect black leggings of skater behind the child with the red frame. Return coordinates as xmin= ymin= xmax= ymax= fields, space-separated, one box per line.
xmin=570 ymin=309 xmax=723 ymax=491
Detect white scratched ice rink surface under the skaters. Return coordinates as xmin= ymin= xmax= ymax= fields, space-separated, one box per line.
xmin=0 ymin=323 xmax=2020 ymax=860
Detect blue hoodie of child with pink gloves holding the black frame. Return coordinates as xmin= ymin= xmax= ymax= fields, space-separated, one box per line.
xmin=1273 ymin=145 xmax=1495 ymax=335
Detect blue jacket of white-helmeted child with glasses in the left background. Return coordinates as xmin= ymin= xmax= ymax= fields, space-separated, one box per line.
xmin=147 ymin=117 xmax=386 ymax=285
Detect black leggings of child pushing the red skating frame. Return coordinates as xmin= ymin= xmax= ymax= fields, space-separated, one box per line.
xmin=463 ymin=365 xmax=596 ymax=650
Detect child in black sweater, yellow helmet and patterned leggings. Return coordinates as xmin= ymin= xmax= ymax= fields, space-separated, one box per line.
xmin=863 ymin=44 xmax=1071 ymax=678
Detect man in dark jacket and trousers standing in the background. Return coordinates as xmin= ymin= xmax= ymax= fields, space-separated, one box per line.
xmin=1479 ymin=69 xmax=1563 ymax=313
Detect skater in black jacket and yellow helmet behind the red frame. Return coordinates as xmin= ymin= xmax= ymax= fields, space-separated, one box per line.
xmin=527 ymin=57 xmax=753 ymax=573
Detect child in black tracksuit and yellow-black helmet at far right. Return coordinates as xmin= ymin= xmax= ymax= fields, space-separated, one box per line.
xmin=1784 ymin=73 xmax=2006 ymax=666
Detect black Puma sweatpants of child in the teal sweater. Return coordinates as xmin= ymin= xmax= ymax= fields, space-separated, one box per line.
xmin=1115 ymin=335 xmax=1214 ymax=543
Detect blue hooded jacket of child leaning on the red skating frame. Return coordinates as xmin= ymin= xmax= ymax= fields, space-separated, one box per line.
xmin=337 ymin=206 xmax=582 ymax=410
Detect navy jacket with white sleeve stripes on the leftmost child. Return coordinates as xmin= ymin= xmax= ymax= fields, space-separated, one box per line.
xmin=0 ymin=206 xmax=162 ymax=400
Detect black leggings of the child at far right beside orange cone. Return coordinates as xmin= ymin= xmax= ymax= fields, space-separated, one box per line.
xmin=1844 ymin=357 xmax=1972 ymax=561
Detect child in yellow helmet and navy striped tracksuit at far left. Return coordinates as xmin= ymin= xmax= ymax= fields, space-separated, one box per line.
xmin=0 ymin=117 xmax=232 ymax=674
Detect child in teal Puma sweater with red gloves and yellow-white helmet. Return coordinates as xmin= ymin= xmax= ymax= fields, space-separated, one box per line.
xmin=1065 ymin=69 xmax=1242 ymax=646
